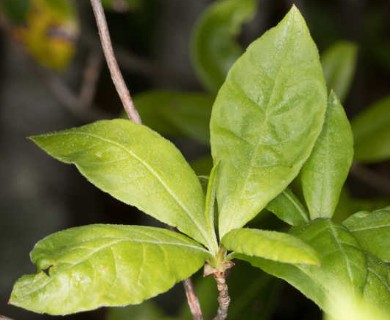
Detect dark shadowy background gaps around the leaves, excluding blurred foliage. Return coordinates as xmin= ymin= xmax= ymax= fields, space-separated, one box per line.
xmin=0 ymin=0 xmax=390 ymax=320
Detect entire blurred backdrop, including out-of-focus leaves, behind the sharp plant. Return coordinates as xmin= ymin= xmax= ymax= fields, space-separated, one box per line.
xmin=0 ymin=0 xmax=390 ymax=320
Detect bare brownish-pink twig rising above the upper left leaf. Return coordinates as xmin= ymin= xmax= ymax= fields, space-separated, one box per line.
xmin=91 ymin=0 xmax=141 ymax=124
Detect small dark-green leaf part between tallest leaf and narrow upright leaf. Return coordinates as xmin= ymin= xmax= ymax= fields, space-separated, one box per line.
xmin=266 ymin=188 xmax=309 ymax=226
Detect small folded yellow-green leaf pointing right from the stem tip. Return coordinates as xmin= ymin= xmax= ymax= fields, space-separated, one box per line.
xmin=221 ymin=229 xmax=320 ymax=265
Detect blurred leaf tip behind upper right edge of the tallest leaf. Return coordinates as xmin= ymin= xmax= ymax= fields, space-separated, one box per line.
xmin=321 ymin=41 xmax=357 ymax=102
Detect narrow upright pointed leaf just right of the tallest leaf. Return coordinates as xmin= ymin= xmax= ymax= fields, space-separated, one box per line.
xmin=300 ymin=92 xmax=353 ymax=220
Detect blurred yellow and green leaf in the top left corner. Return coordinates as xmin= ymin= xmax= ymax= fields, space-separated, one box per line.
xmin=2 ymin=0 xmax=79 ymax=70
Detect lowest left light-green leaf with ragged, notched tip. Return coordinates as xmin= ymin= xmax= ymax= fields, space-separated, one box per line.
xmin=10 ymin=225 xmax=209 ymax=315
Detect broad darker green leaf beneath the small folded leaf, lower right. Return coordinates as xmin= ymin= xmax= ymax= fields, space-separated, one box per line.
xmin=236 ymin=219 xmax=368 ymax=311
